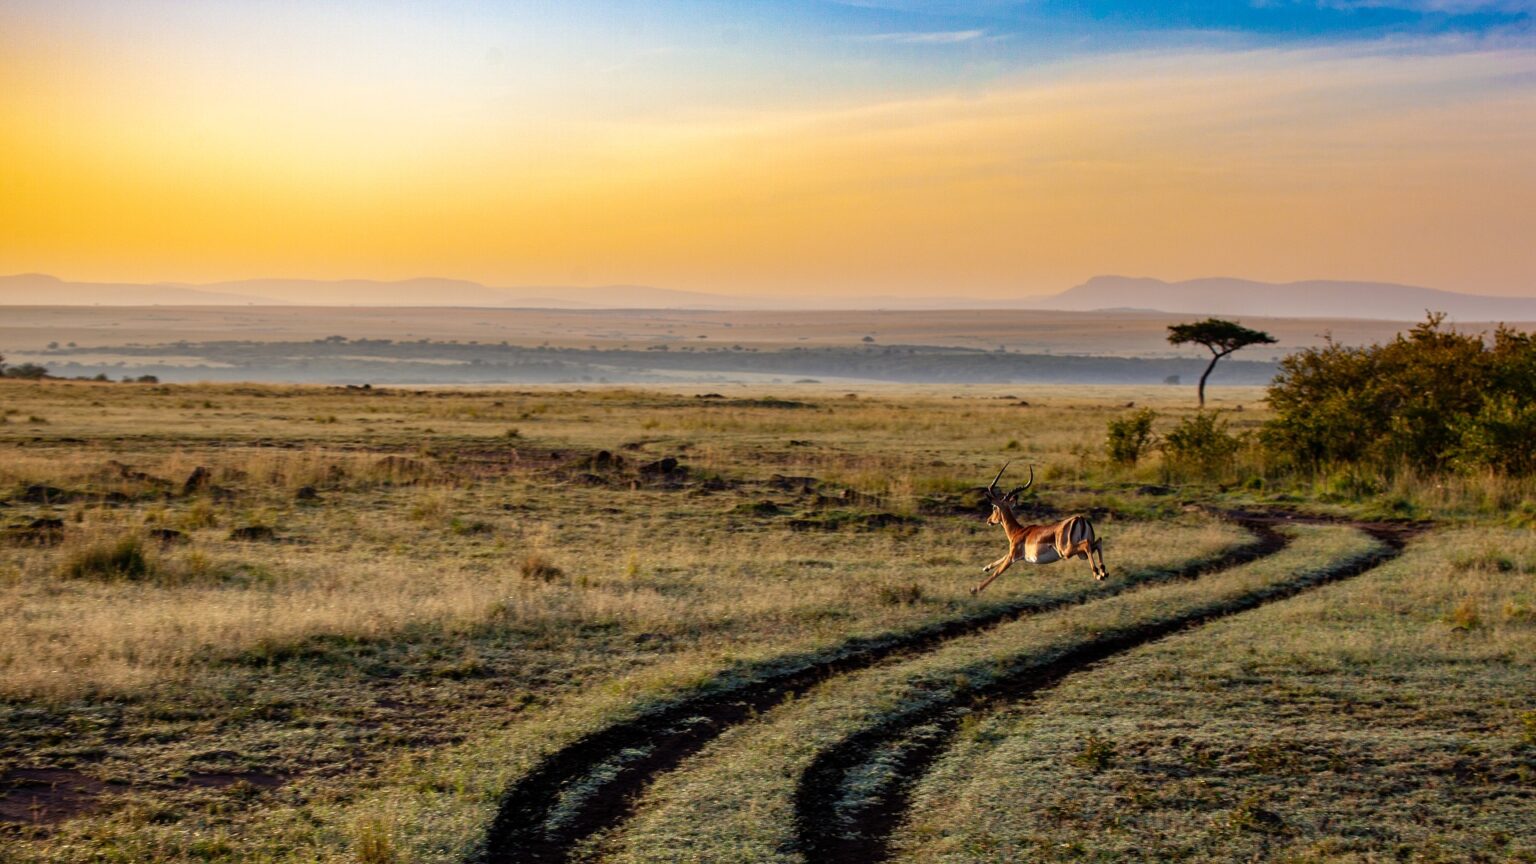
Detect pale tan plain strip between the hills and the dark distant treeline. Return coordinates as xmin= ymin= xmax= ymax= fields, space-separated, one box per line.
xmin=0 ymin=306 xmax=1493 ymax=358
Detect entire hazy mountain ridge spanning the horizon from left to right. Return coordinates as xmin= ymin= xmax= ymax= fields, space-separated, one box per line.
xmin=0 ymin=274 xmax=1536 ymax=321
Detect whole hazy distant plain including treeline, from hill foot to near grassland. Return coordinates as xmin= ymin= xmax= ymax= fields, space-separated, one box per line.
xmin=0 ymin=306 xmax=1523 ymax=386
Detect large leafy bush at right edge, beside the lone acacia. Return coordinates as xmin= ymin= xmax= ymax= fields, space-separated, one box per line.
xmin=1263 ymin=315 xmax=1536 ymax=474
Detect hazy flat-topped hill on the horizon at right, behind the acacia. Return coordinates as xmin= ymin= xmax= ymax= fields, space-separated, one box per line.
xmin=1032 ymin=275 xmax=1536 ymax=321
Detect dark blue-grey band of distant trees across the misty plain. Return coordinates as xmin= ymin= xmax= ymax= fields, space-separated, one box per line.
xmin=36 ymin=337 xmax=1276 ymax=384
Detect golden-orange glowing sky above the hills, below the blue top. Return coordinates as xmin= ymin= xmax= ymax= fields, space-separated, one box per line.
xmin=0 ymin=0 xmax=1536 ymax=297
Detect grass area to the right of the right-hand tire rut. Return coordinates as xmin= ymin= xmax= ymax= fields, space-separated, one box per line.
xmin=900 ymin=529 xmax=1536 ymax=862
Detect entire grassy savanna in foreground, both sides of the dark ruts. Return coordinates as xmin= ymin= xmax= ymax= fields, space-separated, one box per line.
xmin=0 ymin=381 xmax=1536 ymax=862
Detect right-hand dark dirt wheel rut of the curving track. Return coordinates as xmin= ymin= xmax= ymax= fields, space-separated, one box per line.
xmin=794 ymin=513 xmax=1424 ymax=864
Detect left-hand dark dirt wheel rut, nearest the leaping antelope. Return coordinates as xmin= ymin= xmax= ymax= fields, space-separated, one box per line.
xmin=472 ymin=513 xmax=1290 ymax=864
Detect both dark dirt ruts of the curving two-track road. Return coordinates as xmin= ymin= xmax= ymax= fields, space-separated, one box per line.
xmin=475 ymin=512 xmax=1415 ymax=864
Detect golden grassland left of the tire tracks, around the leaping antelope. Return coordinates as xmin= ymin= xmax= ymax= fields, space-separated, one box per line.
xmin=0 ymin=381 xmax=1536 ymax=861
